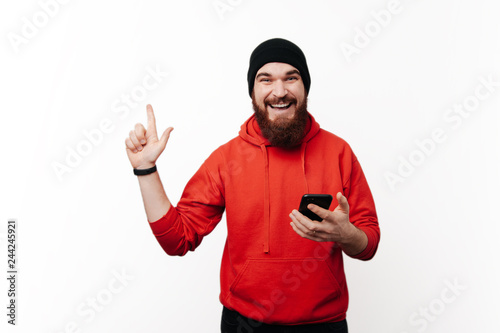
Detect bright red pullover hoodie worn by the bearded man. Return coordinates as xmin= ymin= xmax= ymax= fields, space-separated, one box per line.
xmin=150 ymin=115 xmax=380 ymax=325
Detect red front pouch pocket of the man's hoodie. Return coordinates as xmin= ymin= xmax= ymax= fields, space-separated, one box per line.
xmin=229 ymin=258 xmax=347 ymax=324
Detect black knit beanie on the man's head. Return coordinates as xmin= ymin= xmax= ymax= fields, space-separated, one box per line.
xmin=247 ymin=38 xmax=311 ymax=96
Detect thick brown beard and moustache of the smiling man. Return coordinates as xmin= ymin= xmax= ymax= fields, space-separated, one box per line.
xmin=252 ymin=92 xmax=309 ymax=148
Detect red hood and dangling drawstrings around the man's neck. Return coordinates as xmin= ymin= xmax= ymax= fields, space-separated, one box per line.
xmin=239 ymin=113 xmax=320 ymax=253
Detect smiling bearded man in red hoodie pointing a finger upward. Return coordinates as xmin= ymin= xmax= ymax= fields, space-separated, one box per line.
xmin=125 ymin=38 xmax=380 ymax=333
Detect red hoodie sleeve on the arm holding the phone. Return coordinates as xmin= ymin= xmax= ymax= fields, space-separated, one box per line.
xmin=343 ymin=154 xmax=380 ymax=260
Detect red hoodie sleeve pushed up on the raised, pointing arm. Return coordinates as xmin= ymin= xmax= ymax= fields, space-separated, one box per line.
xmin=148 ymin=151 xmax=225 ymax=256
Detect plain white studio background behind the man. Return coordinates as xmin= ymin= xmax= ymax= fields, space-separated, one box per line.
xmin=0 ymin=0 xmax=500 ymax=333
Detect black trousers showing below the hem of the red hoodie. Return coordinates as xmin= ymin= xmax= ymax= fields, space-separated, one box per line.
xmin=220 ymin=307 xmax=347 ymax=333
